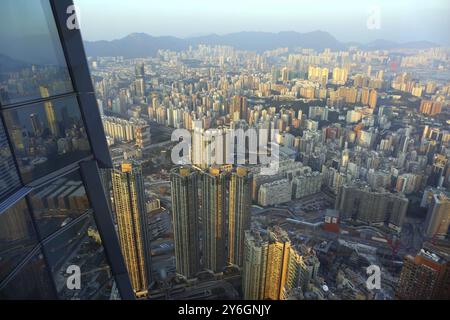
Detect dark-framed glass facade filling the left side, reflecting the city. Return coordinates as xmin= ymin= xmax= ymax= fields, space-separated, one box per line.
xmin=0 ymin=0 xmax=134 ymax=299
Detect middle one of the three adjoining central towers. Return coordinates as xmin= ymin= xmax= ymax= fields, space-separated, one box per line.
xmin=201 ymin=168 xmax=227 ymax=272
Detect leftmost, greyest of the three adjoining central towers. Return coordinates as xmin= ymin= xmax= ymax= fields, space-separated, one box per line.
xmin=170 ymin=167 xmax=200 ymax=278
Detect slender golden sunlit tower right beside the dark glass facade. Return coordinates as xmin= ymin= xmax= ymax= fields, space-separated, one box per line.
xmin=111 ymin=163 xmax=151 ymax=297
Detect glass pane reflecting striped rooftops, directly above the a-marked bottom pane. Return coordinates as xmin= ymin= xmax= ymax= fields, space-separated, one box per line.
xmin=29 ymin=171 xmax=90 ymax=238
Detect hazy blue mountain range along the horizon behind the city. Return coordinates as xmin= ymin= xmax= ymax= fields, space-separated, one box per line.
xmin=81 ymin=31 xmax=439 ymax=58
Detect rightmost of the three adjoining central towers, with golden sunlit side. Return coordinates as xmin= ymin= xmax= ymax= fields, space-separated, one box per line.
xmin=228 ymin=167 xmax=251 ymax=267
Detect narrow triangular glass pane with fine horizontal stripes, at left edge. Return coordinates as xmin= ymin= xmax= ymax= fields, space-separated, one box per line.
xmin=0 ymin=122 xmax=20 ymax=201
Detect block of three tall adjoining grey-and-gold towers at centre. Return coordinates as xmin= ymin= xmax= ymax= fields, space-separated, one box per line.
xmin=171 ymin=166 xmax=252 ymax=278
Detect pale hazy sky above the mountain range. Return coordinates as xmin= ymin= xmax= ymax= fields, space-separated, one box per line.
xmin=74 ymin=0 xmax=450 ymax=45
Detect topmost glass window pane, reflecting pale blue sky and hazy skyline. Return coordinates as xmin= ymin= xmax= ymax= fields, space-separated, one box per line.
xmin=0 ymin=0 xmax=73 ymax=105
